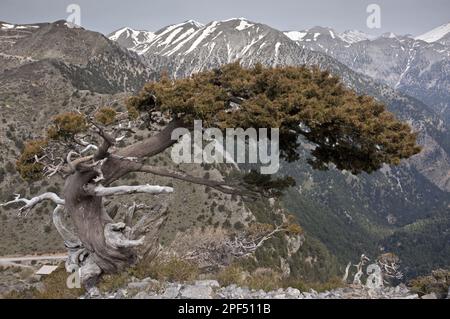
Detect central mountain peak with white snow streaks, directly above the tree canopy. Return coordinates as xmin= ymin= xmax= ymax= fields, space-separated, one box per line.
xmin=125 ymin=18 xmax=322 ymax=77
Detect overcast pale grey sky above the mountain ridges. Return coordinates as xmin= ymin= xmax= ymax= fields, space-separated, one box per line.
xmin=0 ymin=0 xmax=450 ymax=35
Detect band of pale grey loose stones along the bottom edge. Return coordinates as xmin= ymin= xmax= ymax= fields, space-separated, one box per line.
xmin=81 ymin=278 xmax=437 ymax=299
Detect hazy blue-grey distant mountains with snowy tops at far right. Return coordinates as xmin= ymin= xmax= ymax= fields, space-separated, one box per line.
xmin=286 ymin=24 xmax=450 ymax=122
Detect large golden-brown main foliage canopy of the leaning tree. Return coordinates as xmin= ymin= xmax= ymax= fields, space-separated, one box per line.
xmin=127 ymin=62 xmax=420 ymax=174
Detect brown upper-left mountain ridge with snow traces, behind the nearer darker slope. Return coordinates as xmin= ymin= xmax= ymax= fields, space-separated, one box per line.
xmin=0 ymin=21 xmax=152 ymax=94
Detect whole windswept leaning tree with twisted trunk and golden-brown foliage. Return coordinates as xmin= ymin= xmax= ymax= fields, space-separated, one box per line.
xmin=3 ymin=63 xmax=420 ymax=286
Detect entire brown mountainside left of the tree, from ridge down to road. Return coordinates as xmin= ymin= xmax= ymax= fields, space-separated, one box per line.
xmin=0 ymin=21 xmax=155 ymax=255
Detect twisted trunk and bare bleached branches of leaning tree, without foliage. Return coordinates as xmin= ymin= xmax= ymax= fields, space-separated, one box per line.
xmin=13 ymin=120 xmax=236 ymax=288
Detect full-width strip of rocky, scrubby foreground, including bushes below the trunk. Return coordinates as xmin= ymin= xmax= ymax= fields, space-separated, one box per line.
xmin=0 ymin=267 xmax=450 ymax=299
